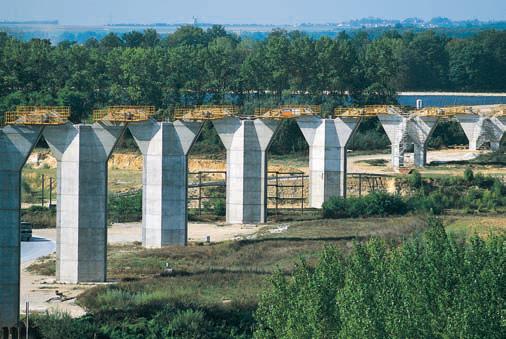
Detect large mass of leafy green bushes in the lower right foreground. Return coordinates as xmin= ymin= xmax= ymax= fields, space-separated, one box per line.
xmin=255 ymin=220 xmax=506 ymax=338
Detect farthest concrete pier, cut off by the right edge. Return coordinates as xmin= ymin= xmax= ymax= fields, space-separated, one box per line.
xmin=455 ymin=114 xmax=506 ymax=151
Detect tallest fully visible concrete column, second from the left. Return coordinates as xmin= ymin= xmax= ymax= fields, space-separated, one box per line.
xmin=44 ymin=123 xmax=124 ymax=283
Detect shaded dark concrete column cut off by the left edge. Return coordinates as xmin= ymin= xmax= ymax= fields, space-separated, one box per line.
xmin=0 ymin=126 xmax=42 ymax=335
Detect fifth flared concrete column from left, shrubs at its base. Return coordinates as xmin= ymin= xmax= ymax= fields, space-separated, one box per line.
xmin=297 ymin=116 xmax=360 ymax=208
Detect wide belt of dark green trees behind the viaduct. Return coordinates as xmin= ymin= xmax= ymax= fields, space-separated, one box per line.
xmin=0 ymin=26 xmax=506 ymax=122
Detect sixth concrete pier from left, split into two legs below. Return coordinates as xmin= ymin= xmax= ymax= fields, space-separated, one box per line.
xmin=378 ymin=114 xmax=439 ymax=170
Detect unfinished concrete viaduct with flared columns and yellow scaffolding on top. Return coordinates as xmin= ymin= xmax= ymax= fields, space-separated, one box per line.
xmin=0 ymin=105 xmax=506 ymax=329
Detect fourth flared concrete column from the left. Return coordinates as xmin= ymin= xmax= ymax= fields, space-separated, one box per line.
xmin=213 ymin=117 xmax=279 ymax=224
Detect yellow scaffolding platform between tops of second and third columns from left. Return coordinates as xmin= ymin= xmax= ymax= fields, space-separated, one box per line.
xmin=93 ymin=106 xmax=155 ymax=122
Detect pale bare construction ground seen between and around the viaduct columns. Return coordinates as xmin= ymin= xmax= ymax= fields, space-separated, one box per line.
xmin=20 ymin=150 xmax=506 ymax=316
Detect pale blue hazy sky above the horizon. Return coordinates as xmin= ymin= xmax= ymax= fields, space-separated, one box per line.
xmin=0 ymin=0 xmax=506 ymax=24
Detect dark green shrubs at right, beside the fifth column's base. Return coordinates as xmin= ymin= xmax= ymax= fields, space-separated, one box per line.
xmin=323 ymin=168 xmax=506 ymax=218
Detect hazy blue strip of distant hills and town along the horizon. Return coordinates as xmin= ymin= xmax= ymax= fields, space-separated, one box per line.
xmin=0 ymin=17 xmax=506 ymax=43
